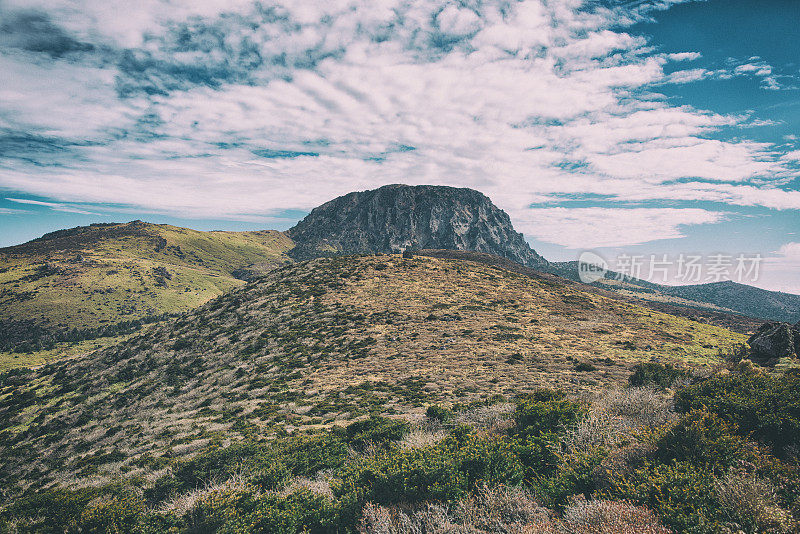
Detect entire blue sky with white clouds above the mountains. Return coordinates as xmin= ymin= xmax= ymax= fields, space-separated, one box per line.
xmin=0 ymin=0 xmax=800 ymax=293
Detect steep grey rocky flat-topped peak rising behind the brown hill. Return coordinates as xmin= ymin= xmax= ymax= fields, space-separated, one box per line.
xmin=288 ymin=185 xmax=547 ymax=266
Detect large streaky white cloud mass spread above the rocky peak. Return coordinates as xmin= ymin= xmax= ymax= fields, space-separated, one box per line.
xmin=0 ymin=0 xmax=800 ymax=253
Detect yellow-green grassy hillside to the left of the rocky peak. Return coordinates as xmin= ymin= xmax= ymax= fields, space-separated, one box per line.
xmin=0 ymin=221 xmax=293 ymax=356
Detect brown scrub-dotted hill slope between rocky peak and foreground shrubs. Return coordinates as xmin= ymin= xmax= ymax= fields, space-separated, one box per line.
xmin=0 ymin=255 xmax=745 ymax=492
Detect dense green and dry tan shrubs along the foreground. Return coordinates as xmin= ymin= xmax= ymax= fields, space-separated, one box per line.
xmin=0 ymin=369 xmax=800 ymax=534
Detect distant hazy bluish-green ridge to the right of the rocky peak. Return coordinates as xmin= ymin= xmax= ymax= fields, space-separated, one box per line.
xmin=541 ymin=261 xmax=800 ymax=323
